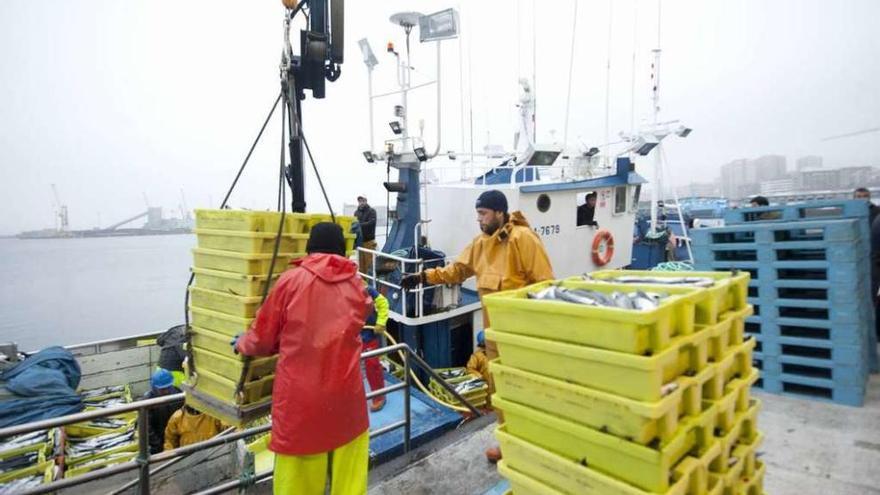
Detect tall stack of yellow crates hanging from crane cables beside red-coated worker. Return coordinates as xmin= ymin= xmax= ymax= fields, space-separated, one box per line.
xmin=184 ymin=210 xmax=354 ymax=426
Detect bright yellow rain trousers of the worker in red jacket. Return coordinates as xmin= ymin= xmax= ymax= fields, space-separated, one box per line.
xmin=274 ymin=431 xmax=370 ymax=495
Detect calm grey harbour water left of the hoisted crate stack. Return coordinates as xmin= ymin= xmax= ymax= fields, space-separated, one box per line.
xmin=0 ymin=235 xmax=195 ymax=351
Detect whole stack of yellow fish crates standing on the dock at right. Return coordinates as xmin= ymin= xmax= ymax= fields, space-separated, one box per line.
xmin=484 ymin=273 xmax=764 ymax=495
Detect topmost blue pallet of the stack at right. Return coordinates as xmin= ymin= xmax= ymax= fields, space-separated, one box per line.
xmin=724 ymin=199 xmax=868 ymax=225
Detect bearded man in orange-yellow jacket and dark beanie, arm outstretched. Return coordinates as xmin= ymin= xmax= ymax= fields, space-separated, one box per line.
xmin=400 ymin=189 xmax=553 ymax=462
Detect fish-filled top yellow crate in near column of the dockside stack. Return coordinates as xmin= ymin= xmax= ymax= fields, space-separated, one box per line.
xmin=483 ymin=279 xmax=717 ymax=355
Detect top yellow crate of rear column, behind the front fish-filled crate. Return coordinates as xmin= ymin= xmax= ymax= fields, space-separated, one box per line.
xmin=578 ymin=270 xmax=751 ymax=322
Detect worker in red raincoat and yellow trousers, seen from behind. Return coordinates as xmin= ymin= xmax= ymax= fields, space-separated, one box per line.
xmin=232 ymin=222 xmax=372 ymax=495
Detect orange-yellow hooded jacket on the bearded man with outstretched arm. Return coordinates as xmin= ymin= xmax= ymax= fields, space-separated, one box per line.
xmin=425 ymin=211 xmax=553 ymax=328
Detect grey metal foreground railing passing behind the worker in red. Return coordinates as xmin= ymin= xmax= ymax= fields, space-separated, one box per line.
xmin=0 ymin=344 xmax=481 ymax=495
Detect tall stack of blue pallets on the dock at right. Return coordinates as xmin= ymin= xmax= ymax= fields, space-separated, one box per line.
xmin=691 ymin=200 xmax=877 ymax=406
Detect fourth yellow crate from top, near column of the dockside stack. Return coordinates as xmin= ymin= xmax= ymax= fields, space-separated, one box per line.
xmin=492 ymin=396 xmax=717 ymax=493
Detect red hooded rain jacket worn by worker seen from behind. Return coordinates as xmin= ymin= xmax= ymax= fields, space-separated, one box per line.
xmin=237 ymin=253 xmax=372 ymax=455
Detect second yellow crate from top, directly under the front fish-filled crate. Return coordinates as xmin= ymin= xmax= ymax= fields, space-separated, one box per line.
xmin=486 ymin=329 xmax=709 ymax=402
